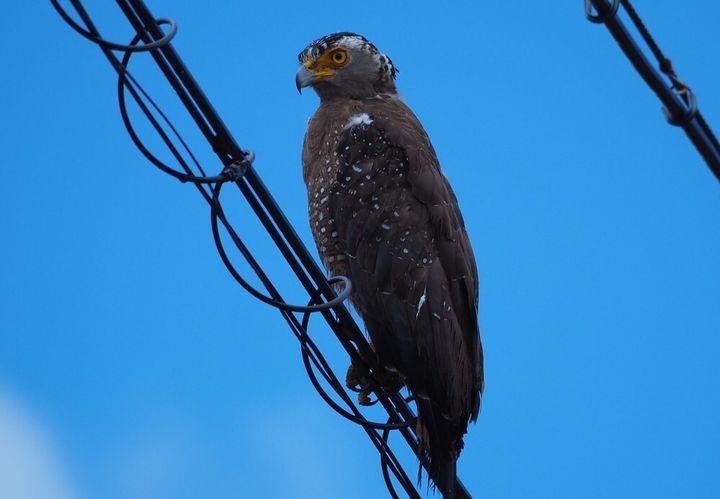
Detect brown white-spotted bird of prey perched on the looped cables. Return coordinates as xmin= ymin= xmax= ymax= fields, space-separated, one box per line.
xmin=296 ymin=33 xmax=483 ymax=495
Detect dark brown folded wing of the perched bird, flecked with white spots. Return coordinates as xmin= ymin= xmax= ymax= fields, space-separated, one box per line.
xmin=329 ymin=98 xmax=483 ymax=438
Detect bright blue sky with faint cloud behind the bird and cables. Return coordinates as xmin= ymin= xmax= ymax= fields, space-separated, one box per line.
xmin=0 ymin=0 xmax=720 ymax=499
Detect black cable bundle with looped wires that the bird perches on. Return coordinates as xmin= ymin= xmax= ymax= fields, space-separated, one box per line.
xmin=50 ymin=0 xmax=471 ymax=499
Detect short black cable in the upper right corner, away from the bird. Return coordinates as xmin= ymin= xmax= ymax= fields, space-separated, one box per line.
xmin=584 ymin=0 xmax=720 ymax=180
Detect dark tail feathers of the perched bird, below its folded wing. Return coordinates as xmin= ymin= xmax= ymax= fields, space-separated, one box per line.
xmin=417 ymin=399 xmax=463 ymax=499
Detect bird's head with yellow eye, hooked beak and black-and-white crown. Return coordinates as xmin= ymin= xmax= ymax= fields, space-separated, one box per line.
xmin=295 ymin=33 xmax=398 ymax=100
